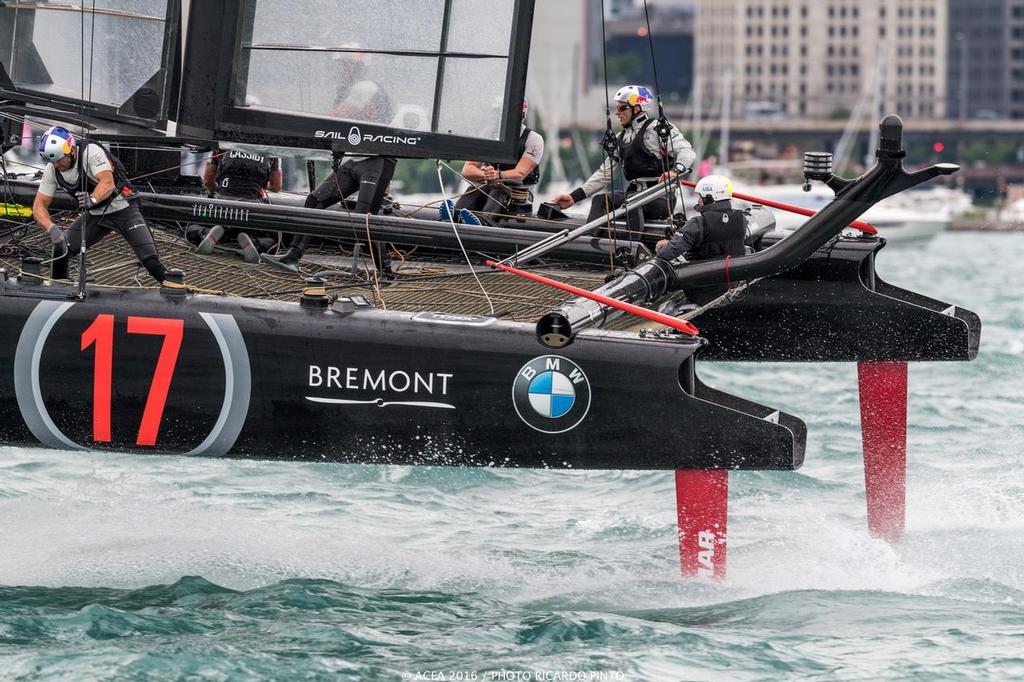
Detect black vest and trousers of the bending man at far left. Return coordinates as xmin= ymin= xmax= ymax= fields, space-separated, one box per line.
xmin=50 ymin=142 xmax=167 ymax=283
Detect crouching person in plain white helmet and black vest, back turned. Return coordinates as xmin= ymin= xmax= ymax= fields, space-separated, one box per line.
xmin=654 ymin=175 xmax=746 ymax=305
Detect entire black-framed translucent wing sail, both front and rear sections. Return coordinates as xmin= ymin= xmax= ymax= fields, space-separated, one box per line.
xmin=0 ymin=0 xmax=535 ymax=162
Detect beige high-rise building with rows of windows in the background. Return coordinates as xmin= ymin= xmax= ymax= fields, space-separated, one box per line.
xmin=694 ymin=0 xmax=949 ymax=118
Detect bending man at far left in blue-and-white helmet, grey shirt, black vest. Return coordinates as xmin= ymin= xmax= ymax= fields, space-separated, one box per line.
xmin=32 ymin=126 xmax=167 ymax=283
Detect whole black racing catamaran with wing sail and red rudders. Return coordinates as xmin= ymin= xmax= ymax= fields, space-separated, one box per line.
xmin=0 ymin=0 xmax=980 ymax=576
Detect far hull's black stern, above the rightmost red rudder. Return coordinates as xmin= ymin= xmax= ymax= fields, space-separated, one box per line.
xmin=695 ymin=233 xmax=981 ymax=363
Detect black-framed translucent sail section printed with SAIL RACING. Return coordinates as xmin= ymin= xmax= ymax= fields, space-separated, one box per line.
xmin=178 ymin=0 xmax=534 ymax=161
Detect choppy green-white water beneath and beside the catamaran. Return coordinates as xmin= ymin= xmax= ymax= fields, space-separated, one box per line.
xmin=0 ymin=233 xmax=1024 ymax=680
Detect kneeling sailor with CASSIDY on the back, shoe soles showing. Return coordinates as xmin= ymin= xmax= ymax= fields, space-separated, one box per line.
xmin=186 ymin=150 xmax=282 ymax=263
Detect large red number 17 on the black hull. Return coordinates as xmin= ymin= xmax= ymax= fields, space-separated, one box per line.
xmin=82 ymin=314 xmax=184 ymax=445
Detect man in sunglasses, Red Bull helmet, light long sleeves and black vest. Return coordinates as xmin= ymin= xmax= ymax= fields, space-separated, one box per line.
xmin=552 ymin=85 xmax=696 ymax=244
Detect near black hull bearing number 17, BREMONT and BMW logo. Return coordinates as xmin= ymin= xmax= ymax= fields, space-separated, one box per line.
xmin=0 ymin=281 xmax=806 ymax=469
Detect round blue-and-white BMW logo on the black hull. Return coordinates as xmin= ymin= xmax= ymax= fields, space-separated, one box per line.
xmin=512 ymin=355 xmax=590 ymax=433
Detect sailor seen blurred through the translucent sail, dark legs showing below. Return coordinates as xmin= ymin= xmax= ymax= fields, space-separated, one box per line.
xmin=262 ymin=52 xmax=398 ymax=280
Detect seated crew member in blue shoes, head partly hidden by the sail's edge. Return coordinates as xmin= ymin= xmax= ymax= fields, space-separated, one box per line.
xmin=440 ymin=99 xmax=544 ymax=225
